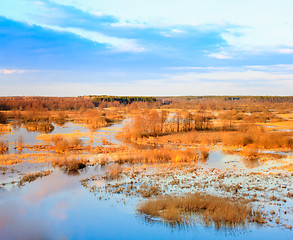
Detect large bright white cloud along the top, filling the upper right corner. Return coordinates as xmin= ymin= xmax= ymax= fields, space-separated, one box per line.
xmin=50 ymin=0 xmax=293 ymax=52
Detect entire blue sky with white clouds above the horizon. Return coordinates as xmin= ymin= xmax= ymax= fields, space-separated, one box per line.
xmin=0 ymin=0 xmax=293 ymax=96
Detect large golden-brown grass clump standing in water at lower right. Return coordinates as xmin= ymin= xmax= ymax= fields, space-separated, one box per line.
xmin=137 ymin=193 xmax=265 ymax=228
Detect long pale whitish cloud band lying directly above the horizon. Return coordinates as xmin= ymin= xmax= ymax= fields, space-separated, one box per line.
xmin=0 ymin=72 xmax=293 ymax=96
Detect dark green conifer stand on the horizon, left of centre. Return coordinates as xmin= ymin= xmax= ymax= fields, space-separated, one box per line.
xmin=89 ymin=95 xmax=157 ymax=105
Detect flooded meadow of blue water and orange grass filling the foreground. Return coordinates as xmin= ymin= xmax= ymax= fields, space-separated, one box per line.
xmin=0 ymin=107 xmax=293 ymax=239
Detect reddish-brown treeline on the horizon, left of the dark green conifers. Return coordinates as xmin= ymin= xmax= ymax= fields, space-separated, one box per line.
xmin=0 ymin=97 xmax=94 ymax=111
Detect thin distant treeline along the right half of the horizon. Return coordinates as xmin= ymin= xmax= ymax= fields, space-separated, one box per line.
xmin=159 ymin=96 xmax=293 ymax=103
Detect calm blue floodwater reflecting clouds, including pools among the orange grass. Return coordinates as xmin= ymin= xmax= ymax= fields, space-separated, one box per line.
xmin=0 ymin=123 xmax=293 ymax=240
